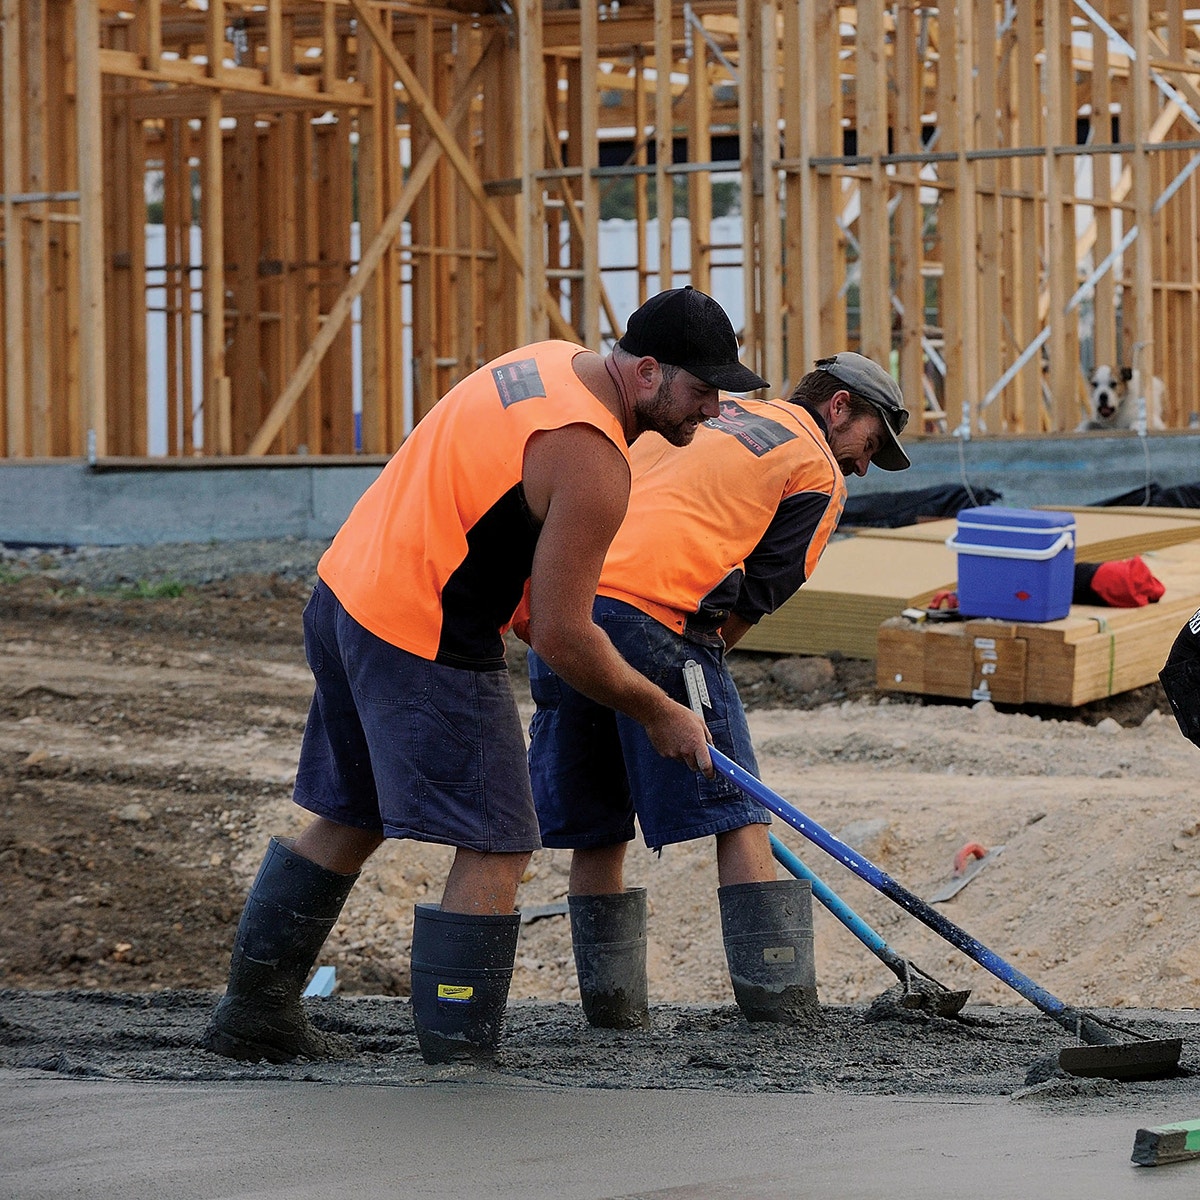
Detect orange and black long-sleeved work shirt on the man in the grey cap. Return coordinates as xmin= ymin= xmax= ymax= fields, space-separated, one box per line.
xmin=599 ymin=397 xmax=846 ymax=643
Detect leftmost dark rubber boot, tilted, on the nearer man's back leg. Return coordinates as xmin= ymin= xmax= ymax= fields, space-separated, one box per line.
xmin=200 ymin=838 xmax=358 ymax=1062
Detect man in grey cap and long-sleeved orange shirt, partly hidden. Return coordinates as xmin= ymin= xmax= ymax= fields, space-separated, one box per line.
xmin=529 ymin=353 xmax=910 ymax=1027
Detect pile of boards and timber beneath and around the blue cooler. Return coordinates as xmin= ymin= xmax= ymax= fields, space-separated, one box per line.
xmin=739 ymin=509 xmax=1200 ymax=706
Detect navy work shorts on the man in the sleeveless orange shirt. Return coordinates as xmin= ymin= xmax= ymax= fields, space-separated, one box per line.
xmin=295 ymin=582 xmax=540 ymax=853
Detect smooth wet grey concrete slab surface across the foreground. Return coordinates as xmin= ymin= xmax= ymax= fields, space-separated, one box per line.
xmin=0 ymin=1070 xmax=1200 ymax=1200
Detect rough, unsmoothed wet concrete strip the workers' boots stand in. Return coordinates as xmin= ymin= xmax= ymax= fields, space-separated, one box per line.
xmin=0 ymin=990 xmax=1200 ymax=1111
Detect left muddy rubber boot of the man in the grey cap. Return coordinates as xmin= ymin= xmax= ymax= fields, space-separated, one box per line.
xmin=566 ymin=888 xmax=650 ymax=1030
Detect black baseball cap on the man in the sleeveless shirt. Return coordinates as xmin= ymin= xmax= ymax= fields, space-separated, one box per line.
xmin=617 ymin=287 xmax=770 ymax=391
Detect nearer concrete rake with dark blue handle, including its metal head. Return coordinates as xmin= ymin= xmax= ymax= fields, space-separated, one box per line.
xmin=708 ymin=746 xmax=1183 ymax=1080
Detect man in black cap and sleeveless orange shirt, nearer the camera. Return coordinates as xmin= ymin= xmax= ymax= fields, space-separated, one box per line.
xmin=202 ymin=288 xmax=767 ymax=1062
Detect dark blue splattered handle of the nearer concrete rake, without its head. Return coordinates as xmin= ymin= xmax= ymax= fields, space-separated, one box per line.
xmin=708 ymin=746 xmax=1116 ymax=1045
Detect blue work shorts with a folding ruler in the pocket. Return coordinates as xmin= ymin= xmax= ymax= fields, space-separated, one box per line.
xmin=529 ymin=596 xmax=770 ymax=850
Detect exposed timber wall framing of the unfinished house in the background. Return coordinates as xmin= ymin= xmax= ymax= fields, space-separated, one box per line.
xmin=0 ymin=0 xmax=1200 ymax=461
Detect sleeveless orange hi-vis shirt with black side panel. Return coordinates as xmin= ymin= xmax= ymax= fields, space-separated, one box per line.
xmin=317 ymin=341 xmax=629 ymax=670
